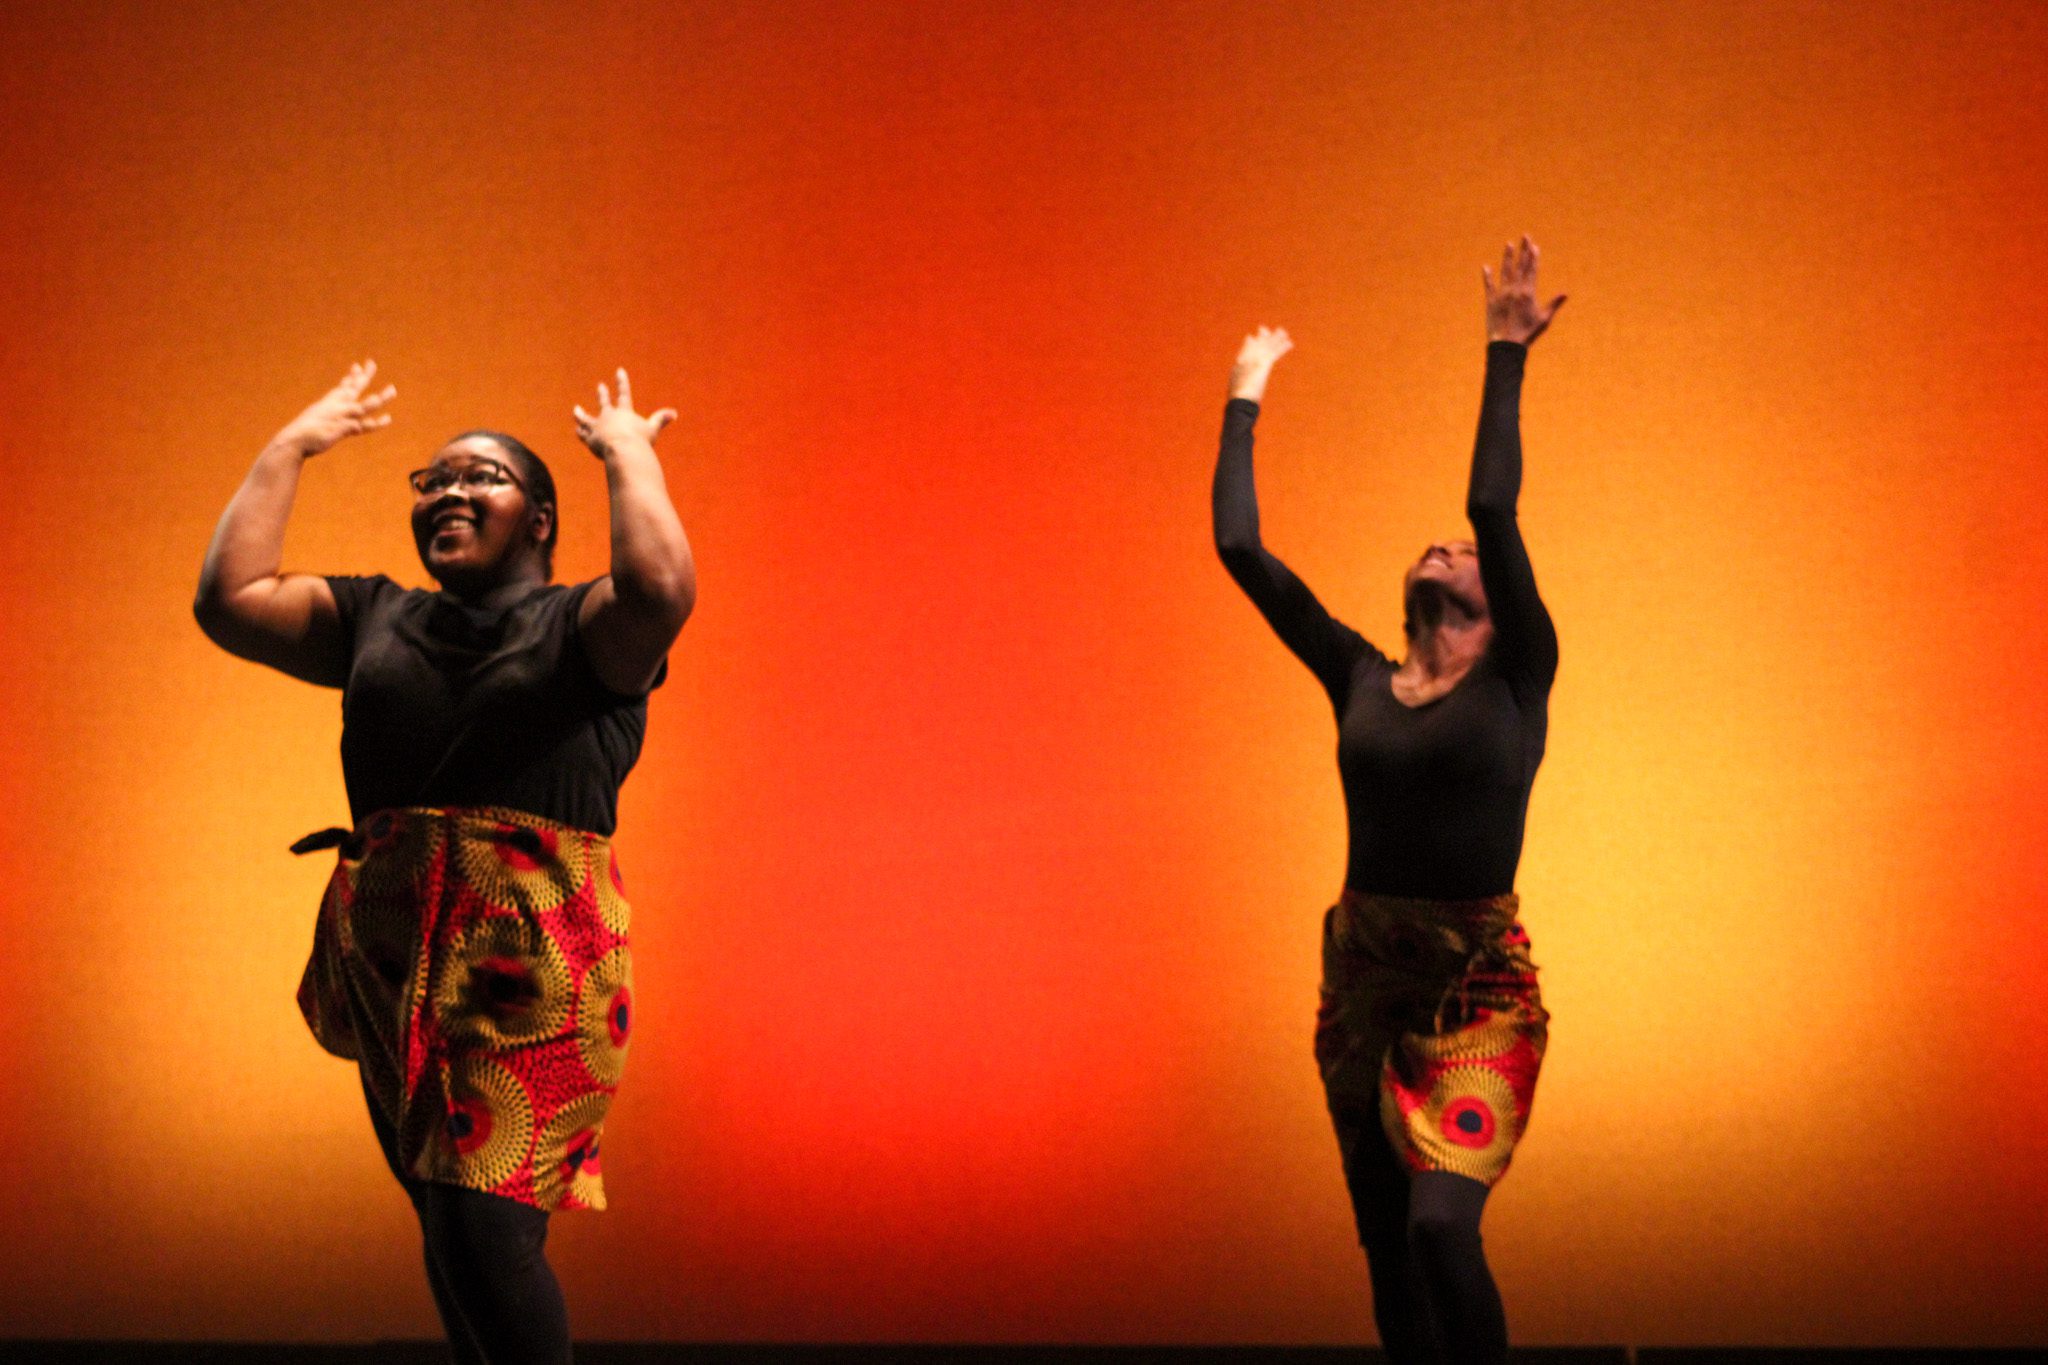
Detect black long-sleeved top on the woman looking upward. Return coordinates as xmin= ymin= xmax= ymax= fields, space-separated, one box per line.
xmin=1210 ymin=342 xmax=1556 ymax=900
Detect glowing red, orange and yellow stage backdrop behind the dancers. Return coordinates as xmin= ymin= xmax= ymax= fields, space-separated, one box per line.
xmin=0 ymin=0 xmax=2048 ymax=1345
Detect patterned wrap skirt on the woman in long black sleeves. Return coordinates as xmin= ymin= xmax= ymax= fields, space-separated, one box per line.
xmin=1315 ymin=888 xmax=1550 ymax=1185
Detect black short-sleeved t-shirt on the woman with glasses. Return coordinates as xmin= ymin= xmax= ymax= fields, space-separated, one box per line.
xmin=328 ymin=573 xmax=668 ymax=835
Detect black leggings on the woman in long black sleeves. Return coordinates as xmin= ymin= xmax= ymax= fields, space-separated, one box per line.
xmin=1331 ymin=1105 xmax=1507 ymax=1365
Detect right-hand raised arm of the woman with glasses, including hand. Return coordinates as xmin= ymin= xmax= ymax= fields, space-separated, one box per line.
xmin=575 ymin=368 xmax=696 ymax=696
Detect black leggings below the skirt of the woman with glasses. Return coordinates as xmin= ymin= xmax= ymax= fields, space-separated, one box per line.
xmin=365 ymin=1089 xmax=569 ymax=1365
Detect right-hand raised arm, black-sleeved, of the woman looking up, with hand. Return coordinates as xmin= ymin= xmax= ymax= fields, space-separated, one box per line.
xmin=1464 ymin=237 xmax=1565 ymax=690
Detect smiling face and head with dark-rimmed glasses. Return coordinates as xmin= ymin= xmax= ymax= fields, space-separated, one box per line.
xmin=412 ymin=436 xmax=555 ymax=591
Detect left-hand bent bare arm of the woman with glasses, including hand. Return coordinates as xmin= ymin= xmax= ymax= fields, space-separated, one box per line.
xmin=193 ymin=360 xmax=397 ymax=686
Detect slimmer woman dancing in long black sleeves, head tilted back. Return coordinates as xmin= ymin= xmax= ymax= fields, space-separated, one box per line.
xmin=1212 ymin=237 xmax=1565 ymax=1365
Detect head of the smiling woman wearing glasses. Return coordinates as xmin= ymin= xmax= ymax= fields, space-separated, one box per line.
xmin=412 ymin=432 xmax=561 ymax=593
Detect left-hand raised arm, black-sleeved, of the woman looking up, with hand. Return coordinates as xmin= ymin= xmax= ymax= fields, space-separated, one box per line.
xmin=1210 ymin=327 xmax=1368 ymax=704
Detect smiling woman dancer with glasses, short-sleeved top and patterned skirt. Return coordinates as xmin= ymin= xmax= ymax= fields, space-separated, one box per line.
xmin=195 ymin=360 xmax=696 ymax=1365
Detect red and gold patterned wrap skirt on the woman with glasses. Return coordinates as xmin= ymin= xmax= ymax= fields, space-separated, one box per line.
xmin=293 ymin=806 xmax=633 ymax=1209
